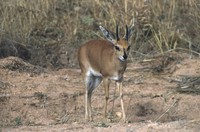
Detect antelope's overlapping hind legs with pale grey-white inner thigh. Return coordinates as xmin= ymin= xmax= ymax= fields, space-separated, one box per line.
xmin=85 ymin=75 xmax=102 ymax=121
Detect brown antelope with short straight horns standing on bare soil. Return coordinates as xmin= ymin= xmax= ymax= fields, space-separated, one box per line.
xmin=78 ymin=26 xmax=133 ymax=121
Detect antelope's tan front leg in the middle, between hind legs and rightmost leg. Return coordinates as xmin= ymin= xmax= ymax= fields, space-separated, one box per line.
xmin=103 ymin=78 xmax=110 ymax=117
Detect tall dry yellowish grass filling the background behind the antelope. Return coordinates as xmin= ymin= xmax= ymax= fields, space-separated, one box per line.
xmin=0 ymin=0 xmax=200 ymax=67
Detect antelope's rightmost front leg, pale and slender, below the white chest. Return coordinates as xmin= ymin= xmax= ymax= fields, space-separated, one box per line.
xmin=117 ymin=82 xmax=126 ymax=122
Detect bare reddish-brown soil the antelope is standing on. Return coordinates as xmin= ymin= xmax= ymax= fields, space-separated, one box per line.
xmin=0 ymin=53 xmax=200 ymax=132
